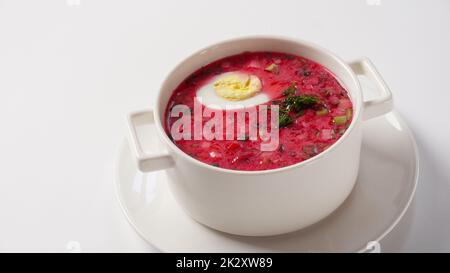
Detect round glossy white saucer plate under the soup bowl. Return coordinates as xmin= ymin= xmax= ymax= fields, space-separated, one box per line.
xmin=115 ymin=112 xmax=419 ymax=252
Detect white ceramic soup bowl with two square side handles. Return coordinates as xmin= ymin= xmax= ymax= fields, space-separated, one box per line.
xmin=128 ymin=36 xmax=392 ymax=236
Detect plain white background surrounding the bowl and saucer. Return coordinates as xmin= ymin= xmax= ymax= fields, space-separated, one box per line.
xmin=0 ymin=0 xmax=450 ymax=252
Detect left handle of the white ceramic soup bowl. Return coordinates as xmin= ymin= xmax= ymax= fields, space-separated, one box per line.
xmin=127 ymin=110 xmax=174 ymax=172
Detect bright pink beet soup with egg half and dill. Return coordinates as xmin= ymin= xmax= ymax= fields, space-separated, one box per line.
xmin=165 ymin=52 xmax=353 ymax=171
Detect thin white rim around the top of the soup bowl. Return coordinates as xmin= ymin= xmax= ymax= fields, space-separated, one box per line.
xmin=153 ymin=35 xmax=363 ymax=175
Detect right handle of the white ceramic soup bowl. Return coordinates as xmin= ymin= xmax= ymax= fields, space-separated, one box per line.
xmin=350 ymin=57 xmax=393 ymax=120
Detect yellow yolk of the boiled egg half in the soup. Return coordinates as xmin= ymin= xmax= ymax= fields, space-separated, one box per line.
xmin=213 ymin=73 xmax=261 ymax=101
